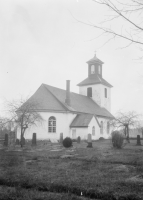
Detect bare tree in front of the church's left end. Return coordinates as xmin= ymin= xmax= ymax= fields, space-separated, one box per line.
xmin=7 ymin=99 xmax=43 ymax=147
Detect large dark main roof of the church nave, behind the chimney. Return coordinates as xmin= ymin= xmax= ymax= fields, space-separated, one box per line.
xmin=27 ymin=84 xmax=114 ymax=118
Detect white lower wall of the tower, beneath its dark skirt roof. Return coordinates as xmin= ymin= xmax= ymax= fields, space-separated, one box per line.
xmin=79 ymin=84 xmax=111 ymax=112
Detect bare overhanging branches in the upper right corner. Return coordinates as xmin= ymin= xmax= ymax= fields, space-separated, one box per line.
xmin=77 ymin=0 xmax=143 ymax=49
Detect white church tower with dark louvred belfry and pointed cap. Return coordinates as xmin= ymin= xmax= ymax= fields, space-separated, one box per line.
xmin=78 ymin=54 xmax=112 ymax=112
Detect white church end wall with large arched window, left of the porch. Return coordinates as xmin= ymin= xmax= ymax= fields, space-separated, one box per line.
xmin=17 ymin=112 xmax=76 ymax=139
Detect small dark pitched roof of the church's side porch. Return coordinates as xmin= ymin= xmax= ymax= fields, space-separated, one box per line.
xmin=70 ymin=114 xmax=93 ymax=127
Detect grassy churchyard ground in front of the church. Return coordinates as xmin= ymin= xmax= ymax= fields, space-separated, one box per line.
xmin=0 ymin=140 xmax=143 ymax=200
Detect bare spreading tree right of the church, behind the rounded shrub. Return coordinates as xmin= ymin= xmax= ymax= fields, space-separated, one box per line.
xmin=110 ymin=111 xmax=140 ymax=142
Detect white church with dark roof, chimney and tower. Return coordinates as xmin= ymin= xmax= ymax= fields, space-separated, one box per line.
xmin=17 ymin=55 xmax=114 ymax=140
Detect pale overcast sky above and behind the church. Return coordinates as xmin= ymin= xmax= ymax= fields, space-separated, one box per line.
xmin=0 ymin=0 xmax=143 ymax=115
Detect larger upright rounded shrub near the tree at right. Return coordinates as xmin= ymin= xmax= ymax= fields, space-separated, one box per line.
xmin=112 ymin=131 xmax=124 ymax=149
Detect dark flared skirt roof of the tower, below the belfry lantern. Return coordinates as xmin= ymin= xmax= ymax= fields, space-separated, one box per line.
xmin=78 ymin=75 xmax=113 ymax=87
